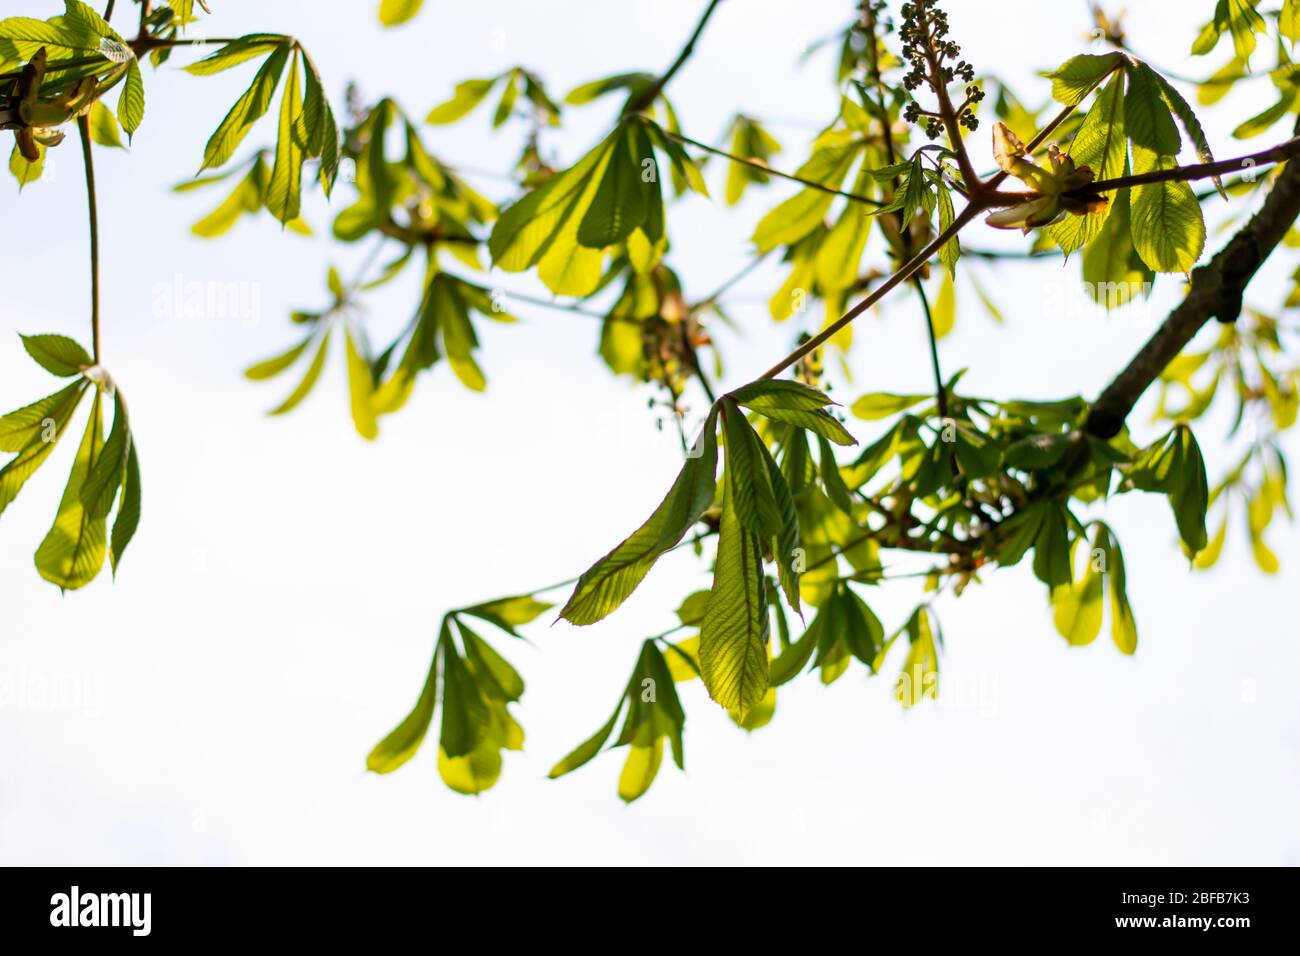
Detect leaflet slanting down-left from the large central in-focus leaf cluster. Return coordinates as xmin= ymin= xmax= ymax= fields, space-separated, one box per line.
xmin=560 ymin=411 xmax=718 ymax=624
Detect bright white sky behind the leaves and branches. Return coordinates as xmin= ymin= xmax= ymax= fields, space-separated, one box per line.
xmin=0 ymin=0 xmax=1300 ymax=865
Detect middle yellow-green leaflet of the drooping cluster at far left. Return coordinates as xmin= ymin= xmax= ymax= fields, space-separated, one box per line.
xmin=36 ymin=392 xmax=108 ymax=591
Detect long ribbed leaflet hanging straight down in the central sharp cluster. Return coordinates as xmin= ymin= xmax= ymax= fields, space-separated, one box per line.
xmin=699 ymin=494 xmax=768 ymax=719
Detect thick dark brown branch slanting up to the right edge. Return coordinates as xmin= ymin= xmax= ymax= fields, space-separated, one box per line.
xmin=1086 ymin=156 xmax=1300 ymax=438
